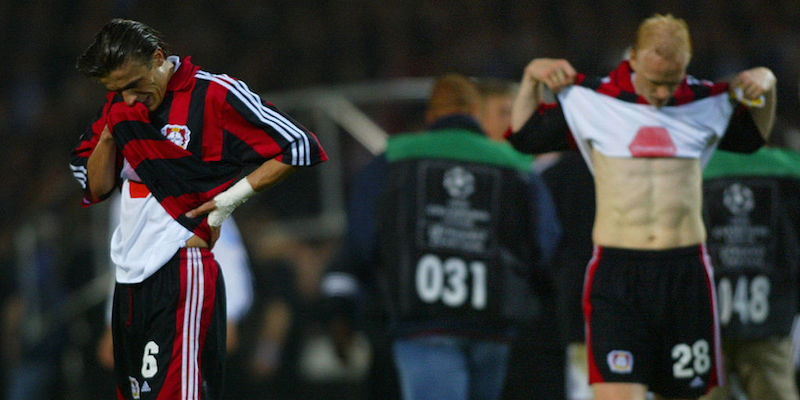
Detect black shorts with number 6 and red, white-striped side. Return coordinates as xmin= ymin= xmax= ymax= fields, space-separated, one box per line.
xmin=111 ymin=248 xmax=226 ymax=400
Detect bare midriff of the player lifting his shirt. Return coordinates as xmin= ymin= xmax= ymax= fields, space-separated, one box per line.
xmin=592 ymin=150 xmax=706 ymax=250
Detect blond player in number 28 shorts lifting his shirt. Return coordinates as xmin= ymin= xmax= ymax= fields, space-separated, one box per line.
xmin=509 ymin=15 xmax=776 ymax=400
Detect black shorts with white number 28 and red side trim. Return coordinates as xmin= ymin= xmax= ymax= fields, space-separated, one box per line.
xmin=583 ymin=245 xmax=722 ymax=398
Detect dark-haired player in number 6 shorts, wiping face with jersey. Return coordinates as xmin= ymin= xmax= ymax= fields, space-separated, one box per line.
xmin=71 ymin=19 xmax=327 ymax=399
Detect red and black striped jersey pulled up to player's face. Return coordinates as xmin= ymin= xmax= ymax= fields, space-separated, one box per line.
xmin=70 ymin=56 xmax=327 ymax=240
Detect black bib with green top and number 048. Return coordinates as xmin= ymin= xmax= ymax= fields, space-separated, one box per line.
xmin=703 ymin=148 xmax=800 ymax=339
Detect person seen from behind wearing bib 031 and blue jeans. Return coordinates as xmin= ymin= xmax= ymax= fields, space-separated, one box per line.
xmin=323 ymin=74 xmax=557 ymax=400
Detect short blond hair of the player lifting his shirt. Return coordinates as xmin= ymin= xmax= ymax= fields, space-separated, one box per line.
xmin=633 ymin=14 xmax=692 ymax=62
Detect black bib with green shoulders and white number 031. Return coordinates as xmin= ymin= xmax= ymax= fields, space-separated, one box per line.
xmin=378 ymin=130 xmax=538 ymax=326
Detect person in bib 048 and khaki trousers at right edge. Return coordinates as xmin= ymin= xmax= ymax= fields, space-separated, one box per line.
xmin=703 ymin=142 xmax=800 ymax=400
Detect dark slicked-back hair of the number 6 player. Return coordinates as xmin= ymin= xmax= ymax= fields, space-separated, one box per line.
xmin=75 ymin=18 xmax=168 ymax=78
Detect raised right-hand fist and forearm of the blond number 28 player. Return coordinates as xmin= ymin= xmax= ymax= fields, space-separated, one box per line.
xmin=731 ymin=67 xmax=777 ymax=140
